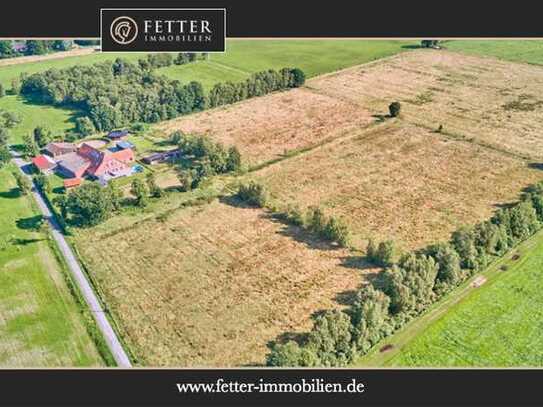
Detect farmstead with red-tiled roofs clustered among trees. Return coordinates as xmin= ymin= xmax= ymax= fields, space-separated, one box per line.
xmin=32 ymin=130 xmax=179 ymax=189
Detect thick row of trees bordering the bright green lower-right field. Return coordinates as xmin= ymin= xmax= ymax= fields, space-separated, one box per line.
xmin=267 ymin=183 xmax=543 ymax=366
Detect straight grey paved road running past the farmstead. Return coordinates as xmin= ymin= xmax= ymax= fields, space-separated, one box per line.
xmin=12 ymin=152 xmax=132 ymax=367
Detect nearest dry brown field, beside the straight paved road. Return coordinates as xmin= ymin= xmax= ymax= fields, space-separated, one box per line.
xmin=72 ymin=200 xmax=362 ymax=367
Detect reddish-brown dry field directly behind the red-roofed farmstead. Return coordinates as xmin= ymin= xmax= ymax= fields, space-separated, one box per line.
xmin=157 ymin=88 xmax=374 ymax=165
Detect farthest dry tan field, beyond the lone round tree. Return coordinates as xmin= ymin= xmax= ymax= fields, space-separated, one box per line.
xmin=308 ymin=50 xmax=543 ymax=159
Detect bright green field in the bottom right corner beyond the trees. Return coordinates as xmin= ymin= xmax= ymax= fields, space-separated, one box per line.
xmin=358 ymin=232 xmax=543 ymax=367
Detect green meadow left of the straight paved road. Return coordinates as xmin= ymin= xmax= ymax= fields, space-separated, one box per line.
xmin=0 ymin=166 xmax=104 ymax=367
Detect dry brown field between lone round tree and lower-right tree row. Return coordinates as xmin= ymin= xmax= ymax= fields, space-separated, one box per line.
xmin=256 ymin=120 xmax=542 ymax=248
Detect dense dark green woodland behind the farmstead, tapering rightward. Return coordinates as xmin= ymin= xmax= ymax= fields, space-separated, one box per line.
xmin=18 ymin=54 xmax=305 ymax=134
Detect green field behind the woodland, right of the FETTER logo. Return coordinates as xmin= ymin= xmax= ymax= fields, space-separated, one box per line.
xmin=159 ymin=40 xmax=416 ymax=89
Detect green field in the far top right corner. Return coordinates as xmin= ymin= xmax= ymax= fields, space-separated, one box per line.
xmin=445 ymin=40 xmax=543 ymax=64
